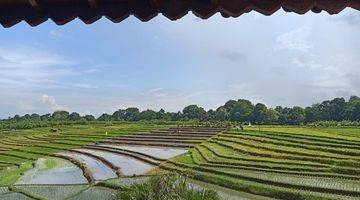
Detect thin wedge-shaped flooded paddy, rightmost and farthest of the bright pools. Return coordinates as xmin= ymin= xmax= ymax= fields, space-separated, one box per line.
xmin=99 ymin=144 xmax=188 ymax=159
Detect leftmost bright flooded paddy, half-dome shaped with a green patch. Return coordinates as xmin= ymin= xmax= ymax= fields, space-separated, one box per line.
xmin=16 ymin=157 xmax=87 ymax=184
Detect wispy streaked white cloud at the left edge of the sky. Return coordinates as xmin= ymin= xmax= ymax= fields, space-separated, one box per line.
xmin=0 ymin=47 xmax=74 ymax=89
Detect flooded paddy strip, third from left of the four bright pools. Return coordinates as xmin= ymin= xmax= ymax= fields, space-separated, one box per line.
xmin=76 ymin=149 xmax=154 ymax=176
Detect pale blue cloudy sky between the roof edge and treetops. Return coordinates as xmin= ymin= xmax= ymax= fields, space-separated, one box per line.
xmin=0 ymin=9 xmax=360 ymax=118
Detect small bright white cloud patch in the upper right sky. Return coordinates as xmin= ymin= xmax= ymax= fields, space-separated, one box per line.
xmin=276 ymin=26 xmax=312 ymax=52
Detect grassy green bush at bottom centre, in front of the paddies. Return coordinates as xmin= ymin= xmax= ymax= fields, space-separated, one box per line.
xmin=117 ymin=174 xmax=219 ymax=200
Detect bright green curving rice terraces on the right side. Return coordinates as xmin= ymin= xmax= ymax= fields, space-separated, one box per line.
xmin=160 ymin=129 xmax=360 ymax=199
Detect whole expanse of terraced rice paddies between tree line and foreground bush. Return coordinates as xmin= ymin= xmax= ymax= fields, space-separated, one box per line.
xmin=0 ymin=124 xmax=360 ymax=199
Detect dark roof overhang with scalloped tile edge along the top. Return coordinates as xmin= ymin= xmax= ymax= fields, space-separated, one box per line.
xmin=0 ymin=0 xmax=360 ymax=27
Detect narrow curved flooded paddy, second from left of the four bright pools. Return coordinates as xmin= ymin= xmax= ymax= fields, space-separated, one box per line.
xmin=60 ymin=152 xmax=117 ymax=180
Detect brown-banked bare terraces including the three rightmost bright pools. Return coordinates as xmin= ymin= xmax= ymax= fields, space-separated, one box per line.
xmin=46 ymin=128 xmax=224 ymax=183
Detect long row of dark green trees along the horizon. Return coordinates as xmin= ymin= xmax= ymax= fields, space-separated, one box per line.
xmin=0 ymin=96 xmax=360 ymax=128
